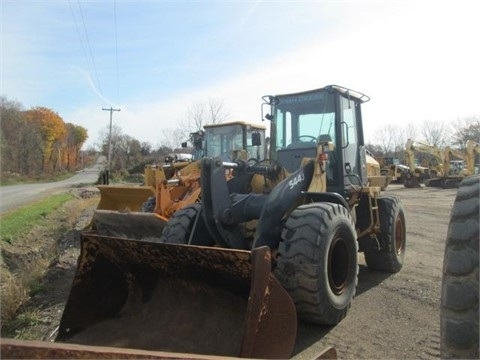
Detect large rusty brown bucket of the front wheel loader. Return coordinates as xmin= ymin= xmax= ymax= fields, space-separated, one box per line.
xmin=56 ymin=233 xmax=297 ymax=358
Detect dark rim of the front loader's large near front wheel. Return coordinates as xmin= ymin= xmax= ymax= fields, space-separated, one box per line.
xmin=328 ymin=235 xmax=349 ymax=295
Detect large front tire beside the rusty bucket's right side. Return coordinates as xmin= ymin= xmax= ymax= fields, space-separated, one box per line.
xmin=274 ymin=203 xmax=358 ymax=325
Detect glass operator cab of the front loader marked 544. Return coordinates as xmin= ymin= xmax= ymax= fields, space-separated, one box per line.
xmin=262 ymin=85 xmax=369 ymax=194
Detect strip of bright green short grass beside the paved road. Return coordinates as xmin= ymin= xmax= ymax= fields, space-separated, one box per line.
xmin=0 ymin=194 xmax=74 ymax=244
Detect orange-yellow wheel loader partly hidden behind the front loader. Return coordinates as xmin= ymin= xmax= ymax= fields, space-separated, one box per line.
xmin=90 ymin=121 xmax=266 ymax=242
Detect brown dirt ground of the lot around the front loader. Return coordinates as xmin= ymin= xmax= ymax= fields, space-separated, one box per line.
xmin=0 ymin=184 xmax=456 ymax=359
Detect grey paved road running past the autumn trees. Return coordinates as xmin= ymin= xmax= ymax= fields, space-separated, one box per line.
xmin=0 ymin=158 xmax=104 ymax=214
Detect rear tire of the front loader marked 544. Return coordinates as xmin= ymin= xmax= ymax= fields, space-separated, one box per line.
xmin=364 ymin=195 xmax=407 ymax=273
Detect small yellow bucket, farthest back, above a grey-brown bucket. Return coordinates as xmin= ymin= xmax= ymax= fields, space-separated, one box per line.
xmin=97 ymin=185 xmax=155 ymax=211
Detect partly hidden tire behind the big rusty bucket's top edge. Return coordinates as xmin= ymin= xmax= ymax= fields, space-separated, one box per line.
xmin=160 ymin=204 xmax=215 ymax=246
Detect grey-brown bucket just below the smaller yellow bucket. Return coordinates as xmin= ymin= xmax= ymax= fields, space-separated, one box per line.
xmin=90 ymin=209 xmax=168 ymax=242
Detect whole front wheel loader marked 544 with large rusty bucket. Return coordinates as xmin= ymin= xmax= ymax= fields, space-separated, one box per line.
xmin=2 ymin=85 xmax=406 ymax=359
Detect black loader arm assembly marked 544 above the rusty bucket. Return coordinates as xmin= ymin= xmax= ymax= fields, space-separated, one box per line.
xmin=202 ymin=158 xmax=314 ymax=249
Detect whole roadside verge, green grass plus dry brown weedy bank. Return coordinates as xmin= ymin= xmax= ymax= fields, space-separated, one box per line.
xmin=0 ymin=193 xmax=98 ymax=330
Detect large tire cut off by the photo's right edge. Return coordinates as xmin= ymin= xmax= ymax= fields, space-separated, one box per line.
xmin=440 ymin=175 xmax=480 ymax=359
